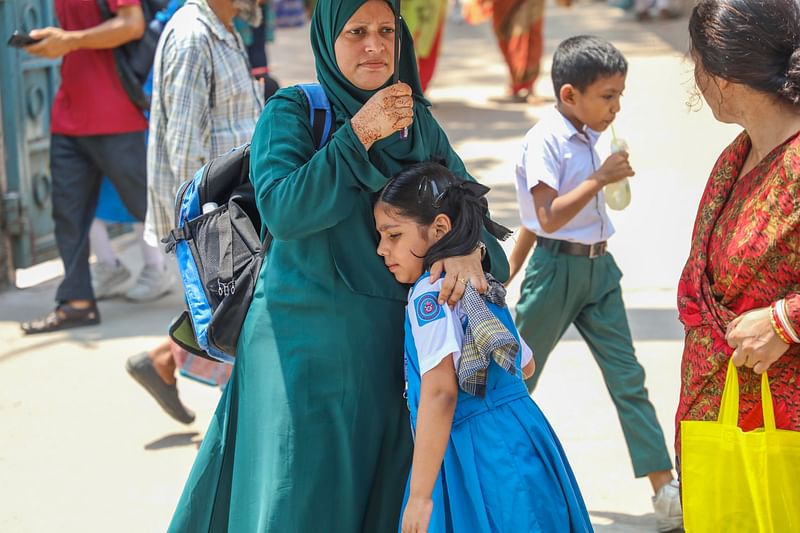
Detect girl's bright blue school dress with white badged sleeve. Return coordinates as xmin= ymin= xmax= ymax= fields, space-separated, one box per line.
xmin=403 ymin=273 xmax=592 ymax=533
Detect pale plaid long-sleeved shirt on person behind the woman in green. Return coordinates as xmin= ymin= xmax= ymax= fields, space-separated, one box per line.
xmin=145 ymin=0 xmax=263 ymax=241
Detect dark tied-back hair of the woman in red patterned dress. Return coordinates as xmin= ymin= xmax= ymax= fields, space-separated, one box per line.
xmin=689 ymin=0 xmax=800 ymax=106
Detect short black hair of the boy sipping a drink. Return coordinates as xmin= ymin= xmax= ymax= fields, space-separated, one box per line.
xmin=550 ymin=35 xmax=628 ymax=101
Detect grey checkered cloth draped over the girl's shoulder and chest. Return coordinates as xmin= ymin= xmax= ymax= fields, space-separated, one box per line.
xmin=456 ymin=274 xmax=519 ymax=398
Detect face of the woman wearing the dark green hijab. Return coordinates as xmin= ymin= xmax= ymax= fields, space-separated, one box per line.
xmin=334 ymin=0 xmax=395 ymax=91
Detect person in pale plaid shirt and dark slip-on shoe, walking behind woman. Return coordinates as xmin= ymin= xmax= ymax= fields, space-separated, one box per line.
xmin=126 ymin=0 xmax=263 ymax=424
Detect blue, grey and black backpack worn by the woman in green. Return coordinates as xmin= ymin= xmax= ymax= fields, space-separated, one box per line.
xmin=163 ymin=83 xmax=333 ymax=363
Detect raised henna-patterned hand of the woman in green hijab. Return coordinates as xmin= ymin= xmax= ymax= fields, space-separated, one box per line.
xmin=350 ymin=82 xmax=414 ymax=150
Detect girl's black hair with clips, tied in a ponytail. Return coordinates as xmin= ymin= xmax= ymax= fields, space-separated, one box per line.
xmin=378 ymin=162 xmax=511 ymax=270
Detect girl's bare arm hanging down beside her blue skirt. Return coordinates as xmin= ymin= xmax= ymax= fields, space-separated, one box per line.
xmin=402 ymin=354 xmax=458 ymax=533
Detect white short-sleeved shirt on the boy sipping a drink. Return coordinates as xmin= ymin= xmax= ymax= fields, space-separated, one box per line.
xmin=516 ymin=108 xmax=614 ymax=244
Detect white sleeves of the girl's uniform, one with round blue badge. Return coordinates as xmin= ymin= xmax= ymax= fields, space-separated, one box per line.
xmin=406 ymin=273 xmax=533 ymax=376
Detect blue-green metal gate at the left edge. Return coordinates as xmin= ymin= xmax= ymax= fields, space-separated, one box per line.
xmin=0 ymin=0 xmax=60 ymax=268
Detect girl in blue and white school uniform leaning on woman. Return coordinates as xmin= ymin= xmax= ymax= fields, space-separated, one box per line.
xmin=374 ymin=163 xmax=592 ymax=533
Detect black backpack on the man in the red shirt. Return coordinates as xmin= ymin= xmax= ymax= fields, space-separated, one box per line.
xmin=97 ymin=0 xmax=169 ymax=111
